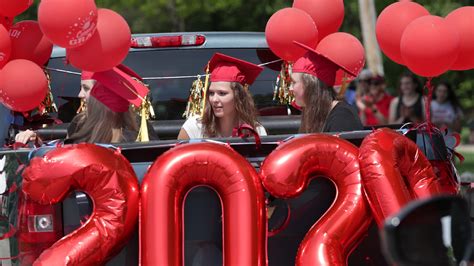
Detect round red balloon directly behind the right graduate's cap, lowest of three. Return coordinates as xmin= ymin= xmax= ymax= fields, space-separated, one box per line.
xmin=316 ymin=32 xmax=365 ymax=86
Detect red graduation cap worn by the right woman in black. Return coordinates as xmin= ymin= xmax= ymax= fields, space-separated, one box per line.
xmin=293 ymin=41 xmax=357 ymax=87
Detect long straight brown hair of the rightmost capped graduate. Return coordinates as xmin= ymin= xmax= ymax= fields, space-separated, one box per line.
xmin=299 ymin=73 xmax=337 ymax=133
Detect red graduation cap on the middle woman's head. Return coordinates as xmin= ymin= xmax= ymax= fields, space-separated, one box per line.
xmin=209 ymin=53 xmax=263 ymax=85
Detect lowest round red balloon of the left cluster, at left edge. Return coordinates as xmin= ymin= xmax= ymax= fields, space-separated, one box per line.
xmin=0 ymin=59 xmax=48 ymax=112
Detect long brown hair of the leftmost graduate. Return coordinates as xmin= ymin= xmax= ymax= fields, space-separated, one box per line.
xmin=69 ymin=96 xmax=138 ymax=143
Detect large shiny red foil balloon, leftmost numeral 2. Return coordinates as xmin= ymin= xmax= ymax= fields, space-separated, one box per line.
xmin=23 ymin=143 xmax=139 ymax=265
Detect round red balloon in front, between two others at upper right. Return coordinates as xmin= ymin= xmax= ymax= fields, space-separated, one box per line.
xmin=400 ymin=16 xmax=460 ymax=77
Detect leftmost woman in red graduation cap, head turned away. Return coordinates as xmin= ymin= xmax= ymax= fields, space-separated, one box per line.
xmin=15 ymin=65 xmax=157 ymax=143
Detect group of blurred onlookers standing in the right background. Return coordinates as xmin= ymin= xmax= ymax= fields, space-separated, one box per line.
xmin=354 ymin=69 xmax=463 ymax=132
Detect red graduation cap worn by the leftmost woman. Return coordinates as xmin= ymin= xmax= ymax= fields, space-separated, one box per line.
xmin=91 ymin=65 xmax=149 ymax=112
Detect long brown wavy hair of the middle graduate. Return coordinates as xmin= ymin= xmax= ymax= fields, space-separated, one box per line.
xmin=201 ymin=82 xmax=259 ymax=138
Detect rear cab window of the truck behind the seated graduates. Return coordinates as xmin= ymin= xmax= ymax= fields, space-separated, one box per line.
xmin=48 ymin=49 xmax=285 ymax=122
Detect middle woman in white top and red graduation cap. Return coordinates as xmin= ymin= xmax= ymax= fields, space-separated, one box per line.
xmin=178 ymin=53 xmax=267 ymax=139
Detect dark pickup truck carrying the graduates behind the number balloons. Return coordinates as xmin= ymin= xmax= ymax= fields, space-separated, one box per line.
xmin=0 ymin=32 xmax=462 ymax=265
